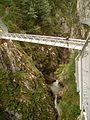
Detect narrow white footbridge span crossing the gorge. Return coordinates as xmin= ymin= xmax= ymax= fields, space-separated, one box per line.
xmin=1 ymin=33 xmax=85 ymax=50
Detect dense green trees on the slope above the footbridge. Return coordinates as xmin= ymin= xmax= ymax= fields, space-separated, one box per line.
xmin=0 ymin=0 xmax=78 ymax=36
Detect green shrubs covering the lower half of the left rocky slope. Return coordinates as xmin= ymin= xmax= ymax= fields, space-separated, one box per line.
xmin=0 ymin=68 xmax=54 ymax=120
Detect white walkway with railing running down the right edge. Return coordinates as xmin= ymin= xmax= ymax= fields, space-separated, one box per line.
xmin=75 ymin=37 xmax=90 ymax=120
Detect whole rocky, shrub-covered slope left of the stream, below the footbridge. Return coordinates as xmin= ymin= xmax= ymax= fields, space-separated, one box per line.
xmin=0 ymin=42 xmax=57 ymax=120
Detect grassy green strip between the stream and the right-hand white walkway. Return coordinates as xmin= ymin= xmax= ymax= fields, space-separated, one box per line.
xmin=56 ymin=52 xmax=80 ymax=120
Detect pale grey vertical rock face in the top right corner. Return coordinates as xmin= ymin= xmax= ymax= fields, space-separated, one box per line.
xmin=77 ymin=0 xmax=90 ymax=22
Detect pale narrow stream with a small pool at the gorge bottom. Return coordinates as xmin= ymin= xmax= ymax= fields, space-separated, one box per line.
xmin=50 ymin=80 xmax=61 ymax=116
